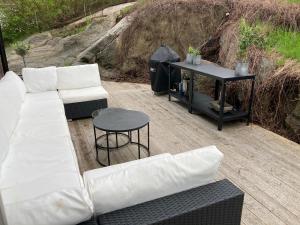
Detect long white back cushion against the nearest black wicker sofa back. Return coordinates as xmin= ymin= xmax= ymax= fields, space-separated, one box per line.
xmin=84 ymin=146 xmax=223 ymax=214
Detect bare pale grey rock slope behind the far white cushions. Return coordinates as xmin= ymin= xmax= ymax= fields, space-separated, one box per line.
xmin=7 ymin=3 xmax=134 ymax=73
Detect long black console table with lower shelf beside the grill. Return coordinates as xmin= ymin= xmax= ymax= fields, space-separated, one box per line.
xmin=169 ymin=61 xmax=255 ymax=130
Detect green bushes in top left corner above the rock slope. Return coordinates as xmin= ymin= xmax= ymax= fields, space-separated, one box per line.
xmin=0 ymin=0 xmax=134 ymax=43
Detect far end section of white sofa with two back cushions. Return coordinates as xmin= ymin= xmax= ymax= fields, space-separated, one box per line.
xmin=22 ymin=64 xmax=108 ymax=119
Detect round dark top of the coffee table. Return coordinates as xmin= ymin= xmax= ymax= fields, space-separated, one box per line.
xmin=93 ymin=108 xmax=150 ymax=132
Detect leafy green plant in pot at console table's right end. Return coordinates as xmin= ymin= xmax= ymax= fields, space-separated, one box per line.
xmin=239 ymin=19 xmax=266 ymax=59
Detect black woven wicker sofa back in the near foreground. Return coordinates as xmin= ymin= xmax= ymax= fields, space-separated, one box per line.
xmin=80 ymin=179 xmax=244 ymax=225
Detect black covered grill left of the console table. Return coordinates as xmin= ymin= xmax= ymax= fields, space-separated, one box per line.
xmin=149 ymin=45 xmax=181 ymax=93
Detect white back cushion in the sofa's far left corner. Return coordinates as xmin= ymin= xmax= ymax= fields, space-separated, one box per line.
xmin=22 ymin=66 xmax=57 ymax=93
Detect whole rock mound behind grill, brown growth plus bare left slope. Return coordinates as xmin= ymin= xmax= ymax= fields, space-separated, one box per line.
xmin=77 ymin=1 xmax=228 ymax=78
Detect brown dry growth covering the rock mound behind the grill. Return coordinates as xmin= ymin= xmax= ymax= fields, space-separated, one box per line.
xmin=117 ymin=1 xmax=229 ymax=75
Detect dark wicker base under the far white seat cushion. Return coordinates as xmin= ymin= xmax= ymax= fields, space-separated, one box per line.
xmin=64 ymin=98 xmax=107 ymax=120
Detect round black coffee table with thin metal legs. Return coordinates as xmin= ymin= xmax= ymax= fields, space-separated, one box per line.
xmin=93 ymin=108 xmax=150 ymax=166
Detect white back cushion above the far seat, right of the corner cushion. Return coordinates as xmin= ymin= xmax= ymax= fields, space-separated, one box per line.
xmin=57 ymin=64 xmax=101 ymax=90
